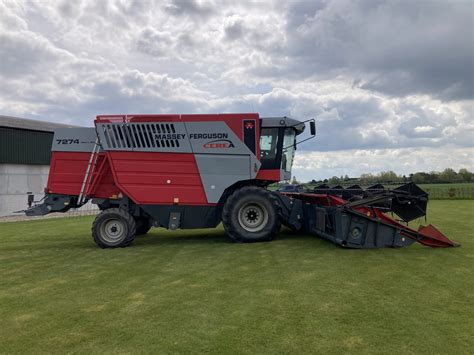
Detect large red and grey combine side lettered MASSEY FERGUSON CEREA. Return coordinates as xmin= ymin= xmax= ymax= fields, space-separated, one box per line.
xmin=96 ymin=115 xmax=261 ymax=205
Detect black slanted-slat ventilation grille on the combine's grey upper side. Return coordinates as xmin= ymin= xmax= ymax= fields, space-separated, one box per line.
xmin=98 ymin=123 xmax=179 ymax=149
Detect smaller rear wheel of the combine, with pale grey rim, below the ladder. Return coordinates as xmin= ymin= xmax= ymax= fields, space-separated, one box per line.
xmin=92 ymin=208 xmax=136 ymax=248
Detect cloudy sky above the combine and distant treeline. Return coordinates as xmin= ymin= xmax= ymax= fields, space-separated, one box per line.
xmin=0 ymin=0 xmax=474 ymax=181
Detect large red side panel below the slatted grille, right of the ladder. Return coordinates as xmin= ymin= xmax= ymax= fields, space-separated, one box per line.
xmin=107 ymin=151 xmax=207 ymax=205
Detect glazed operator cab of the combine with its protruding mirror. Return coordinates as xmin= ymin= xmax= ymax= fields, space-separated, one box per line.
xmin=260 ymin=117 xmax=313 ymax=180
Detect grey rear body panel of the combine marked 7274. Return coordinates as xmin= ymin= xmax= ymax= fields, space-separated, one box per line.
xmin=51 ymin=127 xmax=97 ymax=152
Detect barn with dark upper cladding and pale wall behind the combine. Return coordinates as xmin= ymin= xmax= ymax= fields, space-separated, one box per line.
xmin=0 ymin=115 xmax=78 ymax=216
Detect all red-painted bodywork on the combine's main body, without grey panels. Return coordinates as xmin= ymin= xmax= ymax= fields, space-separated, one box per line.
xmin=47 ymin=113 xmax=280 ymax=206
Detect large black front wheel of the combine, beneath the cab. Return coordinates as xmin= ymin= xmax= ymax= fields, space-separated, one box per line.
xmin=222 ymin=186 xmax=280 ymax=243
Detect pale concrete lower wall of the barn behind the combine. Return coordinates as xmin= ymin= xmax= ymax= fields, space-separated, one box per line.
xmin=0 ymin=164 xmax=49 ymax=216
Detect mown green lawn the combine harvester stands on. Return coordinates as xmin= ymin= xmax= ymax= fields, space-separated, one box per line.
xmin=0 ymin=201 xmax=474 ymax=354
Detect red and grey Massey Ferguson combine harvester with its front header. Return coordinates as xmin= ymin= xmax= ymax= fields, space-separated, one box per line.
xmin=25 ymin=113 xmax=456 ymax=248
